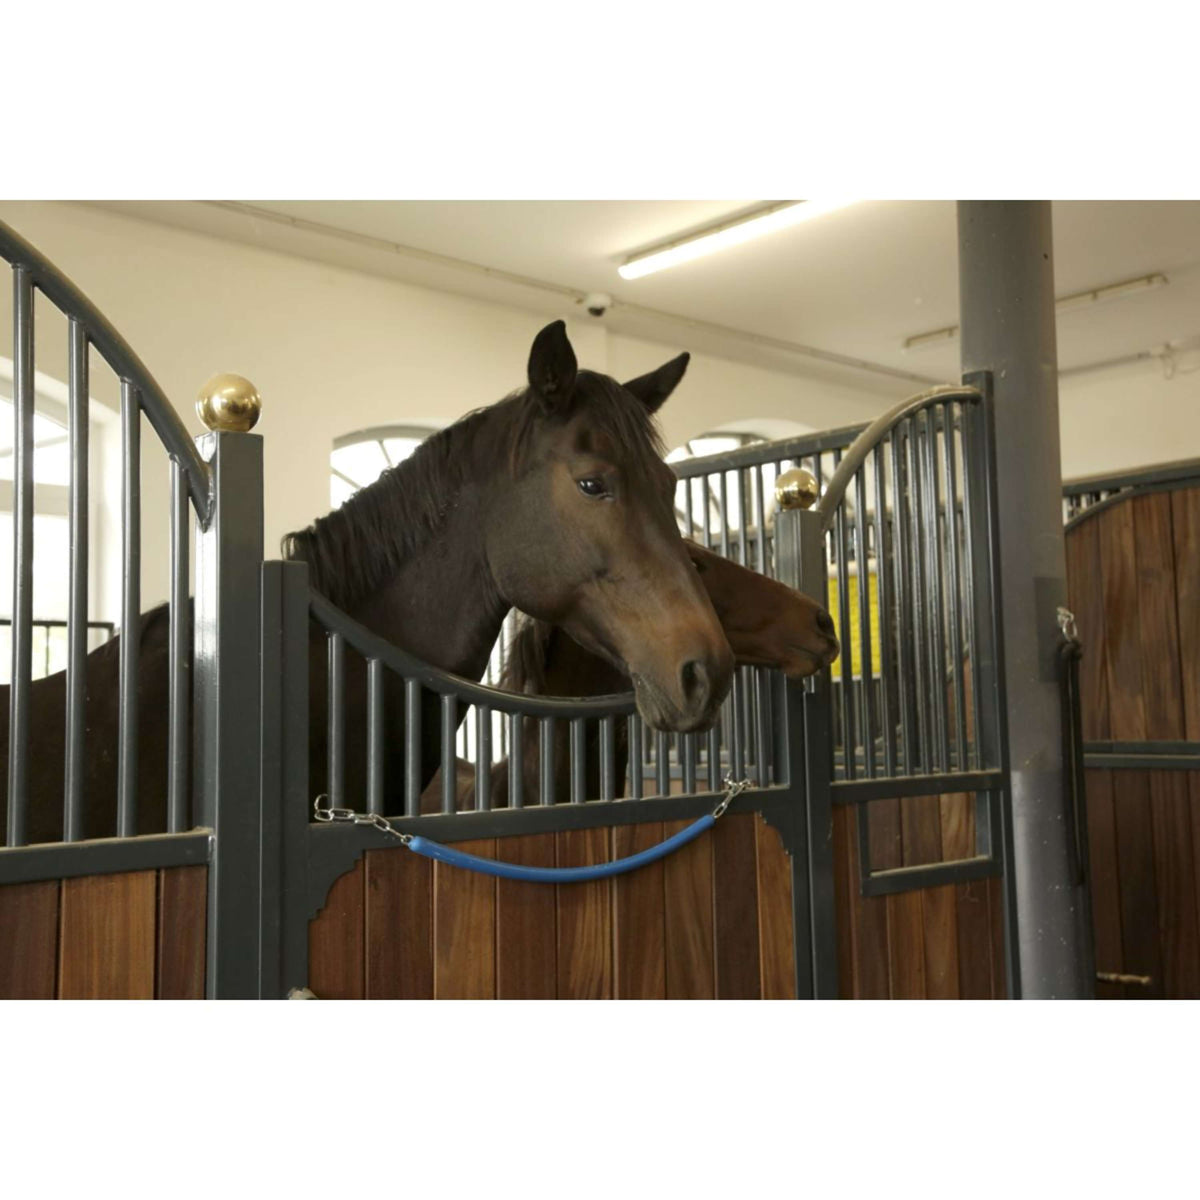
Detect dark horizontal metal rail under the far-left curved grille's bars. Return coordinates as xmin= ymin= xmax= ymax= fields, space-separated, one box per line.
xmin=0 ymin=829 xmax=212 ymax=884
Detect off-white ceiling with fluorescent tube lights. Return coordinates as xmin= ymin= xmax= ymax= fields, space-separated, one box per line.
xmin=88 ymin=200 xmax=1200 ymax=394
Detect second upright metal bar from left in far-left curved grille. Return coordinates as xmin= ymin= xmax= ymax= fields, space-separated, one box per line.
xmin=64 ymin=319 xmax=90 ymax=841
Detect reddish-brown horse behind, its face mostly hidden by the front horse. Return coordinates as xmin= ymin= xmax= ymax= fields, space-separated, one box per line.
xmin=421 ymin=541 xmax=838 ymax=812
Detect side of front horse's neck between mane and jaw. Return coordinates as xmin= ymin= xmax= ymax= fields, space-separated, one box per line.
xmin=350 ymin=488 xmax=508 ymax=679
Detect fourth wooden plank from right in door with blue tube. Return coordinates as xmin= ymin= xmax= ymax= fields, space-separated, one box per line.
xmin=612 ymin=821 xmax=667 ymax=1000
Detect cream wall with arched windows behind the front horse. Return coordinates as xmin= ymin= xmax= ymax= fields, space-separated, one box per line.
xmin=0 ymin=202 xmax=887 ymax=607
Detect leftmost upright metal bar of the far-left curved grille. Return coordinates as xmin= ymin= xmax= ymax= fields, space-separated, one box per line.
xmin=6 ymin=266 xmax=34 ymax=846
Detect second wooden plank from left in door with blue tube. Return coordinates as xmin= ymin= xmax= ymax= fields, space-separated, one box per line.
xmin=364 ymin=850 xmax=433 ymax=1000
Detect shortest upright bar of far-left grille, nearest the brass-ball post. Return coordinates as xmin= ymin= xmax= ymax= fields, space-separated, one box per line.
xmin=167 ymin=458 xmax=192 ymax=833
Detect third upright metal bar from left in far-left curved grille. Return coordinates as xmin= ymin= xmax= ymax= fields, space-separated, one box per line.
xmin=116 ymin=379 xmax=142 ymax=838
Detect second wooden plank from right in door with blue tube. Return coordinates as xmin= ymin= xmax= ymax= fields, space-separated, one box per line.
xmin=713 ymin=812 xmax=762 ymax=1000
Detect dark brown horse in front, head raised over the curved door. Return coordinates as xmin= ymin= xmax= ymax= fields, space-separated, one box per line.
xmin=0 ymin=322 xmax=733 ymax=841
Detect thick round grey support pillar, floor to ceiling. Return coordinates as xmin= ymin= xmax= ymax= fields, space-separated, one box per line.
xmin=958 ymin=200 xmax=1093 ymax=998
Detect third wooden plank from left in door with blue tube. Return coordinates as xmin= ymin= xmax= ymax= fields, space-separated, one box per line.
xmin=433 ymin=838 xmax=497 ymax=1000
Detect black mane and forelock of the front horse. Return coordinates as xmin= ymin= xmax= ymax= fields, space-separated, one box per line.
xmin=282 ymin=371 xmax=664 ymax=608
